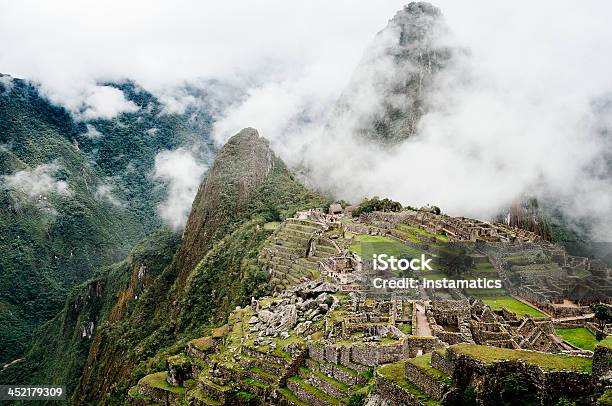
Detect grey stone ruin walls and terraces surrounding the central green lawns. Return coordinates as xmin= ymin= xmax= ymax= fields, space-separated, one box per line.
xmin=130 ymin=208 xmax=612 ymax=406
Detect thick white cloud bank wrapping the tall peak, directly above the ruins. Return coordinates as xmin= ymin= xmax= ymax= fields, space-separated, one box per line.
xmin=210 ymin=2 xmax=612 ymax=241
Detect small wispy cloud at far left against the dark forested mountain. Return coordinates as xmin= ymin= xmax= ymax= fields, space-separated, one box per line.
xmin=2 ymin=163 xmax=71 ymax=200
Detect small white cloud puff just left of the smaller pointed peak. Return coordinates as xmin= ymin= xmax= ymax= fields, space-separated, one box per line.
xmin=153 ymin=148 xmax=206 ymax=230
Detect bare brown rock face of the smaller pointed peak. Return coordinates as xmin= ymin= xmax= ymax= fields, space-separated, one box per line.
xmin=177 ymin=128 xmax=277 ymax=285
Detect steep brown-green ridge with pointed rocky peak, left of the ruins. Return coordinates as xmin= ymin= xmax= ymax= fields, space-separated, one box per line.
xmin=0 ymin=129 xmax=326 ymax=404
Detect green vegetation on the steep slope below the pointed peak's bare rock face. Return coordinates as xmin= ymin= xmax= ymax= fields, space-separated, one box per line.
xmin=0 ymin=132 xmax=325 ymax=404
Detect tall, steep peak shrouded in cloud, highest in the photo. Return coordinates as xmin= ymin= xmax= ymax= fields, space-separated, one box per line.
xmin=328 ymin=2 xmax=455 ymax=143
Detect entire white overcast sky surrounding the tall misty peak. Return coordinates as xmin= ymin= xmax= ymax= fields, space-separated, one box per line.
xmin=0 ymin=0 xmax=612 ymax=238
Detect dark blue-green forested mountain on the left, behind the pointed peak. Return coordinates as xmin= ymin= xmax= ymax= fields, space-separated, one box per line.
xmin=0 ymin=75 xmax=218 ymax=362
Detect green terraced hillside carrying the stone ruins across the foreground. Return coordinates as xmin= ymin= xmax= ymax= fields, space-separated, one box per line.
xmin=128 ymin=206 xmax=609 ymax=406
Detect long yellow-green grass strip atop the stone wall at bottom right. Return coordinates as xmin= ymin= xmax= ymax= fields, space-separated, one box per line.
xmin=450 ymin=344 xmax=593 ymax=372
